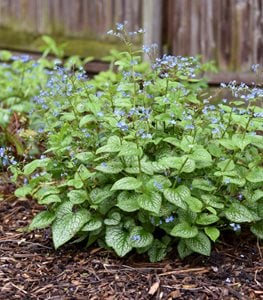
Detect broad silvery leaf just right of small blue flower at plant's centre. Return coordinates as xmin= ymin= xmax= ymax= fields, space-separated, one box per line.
xmin=163 ymin=185 xmax=191 ymax=209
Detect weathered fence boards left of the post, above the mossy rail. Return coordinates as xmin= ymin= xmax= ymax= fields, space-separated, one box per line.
xmin=0 ymin=0 xmax=142 ymax=37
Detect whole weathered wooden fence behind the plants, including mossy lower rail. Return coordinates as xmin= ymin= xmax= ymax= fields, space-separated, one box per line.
xmin=0 ymin=0 xmax=263 ymax=79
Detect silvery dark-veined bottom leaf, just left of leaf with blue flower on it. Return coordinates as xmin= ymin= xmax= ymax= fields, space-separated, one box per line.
xmin=105 ymin=226 xmax=132 ymax=257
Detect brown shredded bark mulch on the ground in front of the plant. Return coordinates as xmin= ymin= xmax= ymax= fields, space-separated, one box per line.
xmin=0 ymin=199 xmax=263 ymax=300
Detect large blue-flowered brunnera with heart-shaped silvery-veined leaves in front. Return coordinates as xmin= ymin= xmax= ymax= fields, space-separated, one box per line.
xmin=14 ymin=24 xmax=263 ymax=262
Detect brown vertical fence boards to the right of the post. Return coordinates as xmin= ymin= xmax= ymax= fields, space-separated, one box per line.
xmin=165 ymin=0 xmax=263 ymax=71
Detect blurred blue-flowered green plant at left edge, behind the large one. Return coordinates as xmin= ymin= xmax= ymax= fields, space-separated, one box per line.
xmin=0 ymin=36 xmax=92 ymax=172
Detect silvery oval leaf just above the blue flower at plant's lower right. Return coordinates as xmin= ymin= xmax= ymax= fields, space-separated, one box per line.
xmin=225 ymin=203 xmax=254 ymax=223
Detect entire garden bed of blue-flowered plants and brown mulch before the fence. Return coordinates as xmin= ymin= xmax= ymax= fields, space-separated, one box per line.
xmin=0 ymin=24 xmax=263 ymax=299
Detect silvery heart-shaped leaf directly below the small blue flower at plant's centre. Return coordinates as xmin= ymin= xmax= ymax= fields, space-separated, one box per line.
xmin=137 ymin=192 xmax=162 ymax=214
